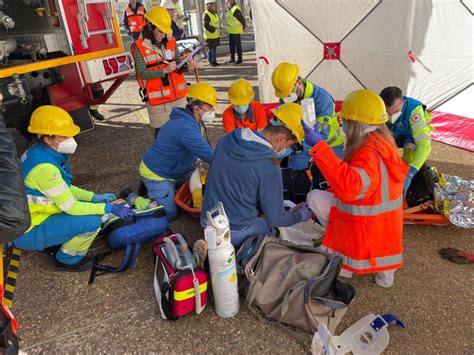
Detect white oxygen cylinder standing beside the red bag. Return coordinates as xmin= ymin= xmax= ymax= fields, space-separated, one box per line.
xmin=205 ymin=202 xmax=240 ymax=318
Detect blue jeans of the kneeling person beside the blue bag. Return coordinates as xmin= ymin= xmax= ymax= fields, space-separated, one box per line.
xmin=143 ymin=170 xmax=192 ymax=221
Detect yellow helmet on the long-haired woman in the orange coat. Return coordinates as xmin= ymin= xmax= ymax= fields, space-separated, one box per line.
xmin=337 ymin=89 xmax=388 ymax=124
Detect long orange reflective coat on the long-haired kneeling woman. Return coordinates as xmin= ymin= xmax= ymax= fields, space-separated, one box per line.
xmin=310 ymin=133 xmax=408 ymax=274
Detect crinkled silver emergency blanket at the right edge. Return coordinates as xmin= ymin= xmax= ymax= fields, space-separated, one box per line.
xmin=434 ymin=174 xmax=474 ymax=228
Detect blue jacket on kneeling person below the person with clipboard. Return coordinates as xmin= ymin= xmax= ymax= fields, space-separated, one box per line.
xmin=143 ymin=107 xmax=214 ymax=179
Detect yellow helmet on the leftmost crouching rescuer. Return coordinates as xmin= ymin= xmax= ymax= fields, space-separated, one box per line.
xmin=28 ymin=105 xmax=81 ymax=137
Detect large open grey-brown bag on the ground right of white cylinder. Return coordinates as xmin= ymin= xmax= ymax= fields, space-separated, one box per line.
xmin=238 ymin=235 xmax=355 ymax=336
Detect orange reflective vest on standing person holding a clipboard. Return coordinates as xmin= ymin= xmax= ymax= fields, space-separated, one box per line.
xmin=132 ymin=37 xmax=188 ymax=106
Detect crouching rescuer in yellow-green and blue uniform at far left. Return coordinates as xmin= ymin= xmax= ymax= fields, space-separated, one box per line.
xmin=13 ymin=105 xmax=134 ymax=271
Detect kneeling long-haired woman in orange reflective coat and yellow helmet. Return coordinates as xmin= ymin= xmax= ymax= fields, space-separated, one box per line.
xmin=303 ymin=90 xmax=408 ymax=287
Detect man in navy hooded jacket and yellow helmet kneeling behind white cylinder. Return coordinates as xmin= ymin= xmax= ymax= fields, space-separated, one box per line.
xmin=201 ymin=103 xmax=312 ymax=247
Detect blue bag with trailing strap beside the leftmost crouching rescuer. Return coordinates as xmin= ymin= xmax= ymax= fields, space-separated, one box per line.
xmin=89 ymin=205 xmax=169 ymax=284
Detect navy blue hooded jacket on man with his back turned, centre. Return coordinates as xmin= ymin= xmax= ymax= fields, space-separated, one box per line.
xmin=201 ymin=128 xmax=301 ymax=231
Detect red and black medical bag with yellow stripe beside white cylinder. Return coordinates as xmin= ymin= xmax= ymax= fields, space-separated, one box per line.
xmin=153 ymin=233 xmax=207 ymax=320
